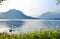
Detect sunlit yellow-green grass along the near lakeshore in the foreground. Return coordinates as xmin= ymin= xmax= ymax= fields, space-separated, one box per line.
xmin=0 ymin=30 xmax=60 ymax=39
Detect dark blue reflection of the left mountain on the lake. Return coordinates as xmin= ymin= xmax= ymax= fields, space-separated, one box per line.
xmin=6 ymin=21 xmax=24 ymax=28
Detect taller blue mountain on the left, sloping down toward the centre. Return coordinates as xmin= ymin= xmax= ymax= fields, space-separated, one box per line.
xmin=0 ymin=9 xmax=37 ymax=19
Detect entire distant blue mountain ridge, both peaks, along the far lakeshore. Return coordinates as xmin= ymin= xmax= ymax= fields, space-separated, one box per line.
xmin=0 ymin=9 xmax=60 ymax=20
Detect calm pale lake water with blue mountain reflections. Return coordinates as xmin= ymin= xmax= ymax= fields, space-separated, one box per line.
xmin=0 ymin=19 xmax=60 ymax=33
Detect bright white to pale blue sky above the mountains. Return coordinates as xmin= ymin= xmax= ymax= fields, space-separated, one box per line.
xmin=0 ymin=0 xmax=60 ymax=17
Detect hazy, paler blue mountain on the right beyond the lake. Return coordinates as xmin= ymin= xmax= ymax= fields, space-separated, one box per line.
xmin=39 ymin=12 xmax=60 ymax=20
